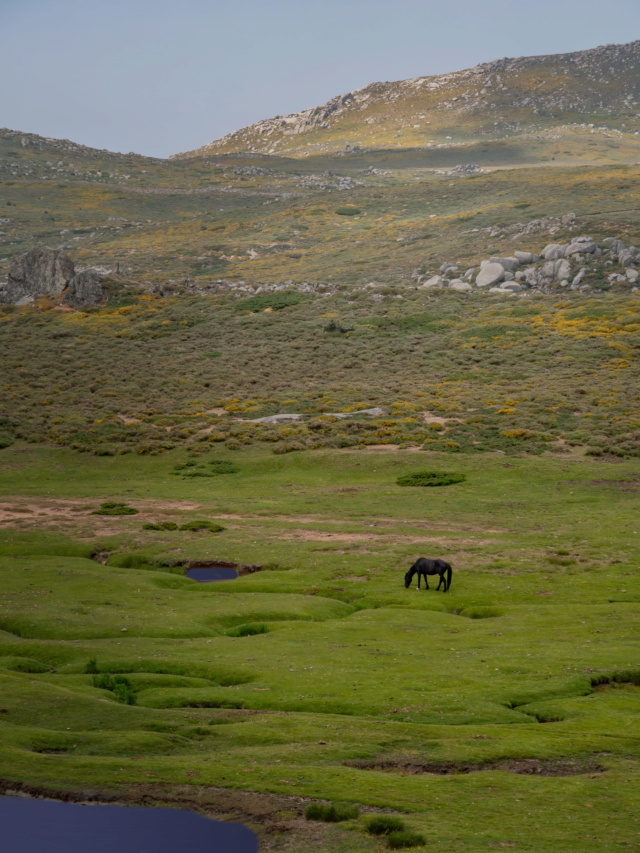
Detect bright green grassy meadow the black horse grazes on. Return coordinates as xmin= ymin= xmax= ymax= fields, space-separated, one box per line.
xmin=0 ymin=441 xmax=640 ymax=853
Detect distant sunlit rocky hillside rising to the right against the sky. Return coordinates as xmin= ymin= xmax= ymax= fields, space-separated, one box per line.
xmin=174 ymin=41 xmax=640 ymax=158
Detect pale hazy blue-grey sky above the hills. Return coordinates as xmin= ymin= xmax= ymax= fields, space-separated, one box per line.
xmin=0 ymin=0 xmax=640 ymax=157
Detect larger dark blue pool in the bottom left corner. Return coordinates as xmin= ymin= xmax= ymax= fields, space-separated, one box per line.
xmin=0 ymin=796 xmax=258 ymax=853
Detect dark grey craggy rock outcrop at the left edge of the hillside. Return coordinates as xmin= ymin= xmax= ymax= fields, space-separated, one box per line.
xmin=0 ymin=246 xmax=104 ymax=308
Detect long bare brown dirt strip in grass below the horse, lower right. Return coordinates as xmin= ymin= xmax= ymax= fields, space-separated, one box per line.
xmin=346 ymin=758 xmax=607 ymax=776
